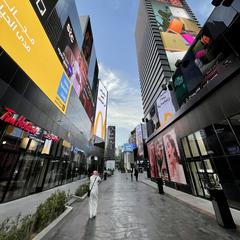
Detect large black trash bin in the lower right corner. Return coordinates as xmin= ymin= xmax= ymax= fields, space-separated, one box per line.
xmin=208 ymin=188 xmax=236 ymax=229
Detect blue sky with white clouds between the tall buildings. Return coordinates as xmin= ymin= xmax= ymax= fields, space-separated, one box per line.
xmin=75 ymin=0 xmax=212 ymax=145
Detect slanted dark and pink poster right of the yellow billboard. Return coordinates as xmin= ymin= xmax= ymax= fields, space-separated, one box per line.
xmin=56 ymin=17 xmax=94 ymax=122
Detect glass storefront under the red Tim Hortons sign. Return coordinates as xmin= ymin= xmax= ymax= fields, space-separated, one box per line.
xmin=0 ymin=107 xmax=87 ymax=202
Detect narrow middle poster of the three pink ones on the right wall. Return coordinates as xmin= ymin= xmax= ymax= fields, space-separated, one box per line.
xmin=154 ymin=136 xmax=169 ymax=180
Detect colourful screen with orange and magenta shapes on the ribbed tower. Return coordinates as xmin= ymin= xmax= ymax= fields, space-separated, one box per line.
xmin=152 ymin=0 xmax=200 ymax=71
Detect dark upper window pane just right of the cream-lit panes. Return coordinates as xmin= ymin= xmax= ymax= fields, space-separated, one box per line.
xmin=214 ymin=120 xmax=240 ymax=155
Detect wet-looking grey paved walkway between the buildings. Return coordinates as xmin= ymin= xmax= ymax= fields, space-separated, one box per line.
xmin=44 ymin=174 xmax=240 ymax=240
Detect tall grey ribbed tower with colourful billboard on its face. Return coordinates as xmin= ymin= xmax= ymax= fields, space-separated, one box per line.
xmin=135 ymin=0 xmax=200 ymax=132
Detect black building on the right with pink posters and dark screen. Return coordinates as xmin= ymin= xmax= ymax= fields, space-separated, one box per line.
xmin=136 ymin=0 xmax=240 ymax=209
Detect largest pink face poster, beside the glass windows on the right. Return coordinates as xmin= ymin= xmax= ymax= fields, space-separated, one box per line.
xmin=163 ymin=129 xmax=186 ymax=184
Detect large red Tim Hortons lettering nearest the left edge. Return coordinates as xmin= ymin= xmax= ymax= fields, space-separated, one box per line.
xmin=0 ymin=107 xmax=37 ymax=134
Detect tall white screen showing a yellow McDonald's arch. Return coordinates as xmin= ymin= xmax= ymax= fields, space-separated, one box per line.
xmin=93 ymin=81 xmax=108 ymax=140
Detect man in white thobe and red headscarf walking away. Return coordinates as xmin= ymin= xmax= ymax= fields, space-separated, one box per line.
xmin=89 ymin=171 xmax=101 ymax=218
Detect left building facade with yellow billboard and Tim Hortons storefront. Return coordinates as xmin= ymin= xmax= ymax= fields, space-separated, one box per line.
xmin=0 ymin=0 xmax=103 ymax=202
